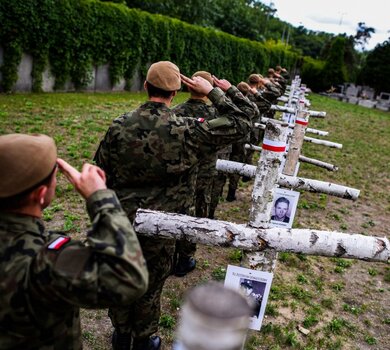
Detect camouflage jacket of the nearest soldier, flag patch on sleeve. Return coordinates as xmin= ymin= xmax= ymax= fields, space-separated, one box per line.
xmin=0 ymin=190 xmax=148 ymax=350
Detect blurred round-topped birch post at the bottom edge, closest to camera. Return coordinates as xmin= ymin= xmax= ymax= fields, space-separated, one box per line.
xmin=173 ymin=282 xmax=252 ymax=350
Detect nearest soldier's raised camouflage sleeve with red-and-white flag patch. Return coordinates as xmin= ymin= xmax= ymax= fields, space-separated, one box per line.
xmin=29 ymin=190 xmax=148 ymax=307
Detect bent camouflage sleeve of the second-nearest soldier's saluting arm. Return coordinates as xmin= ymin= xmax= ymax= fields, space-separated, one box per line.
xmin=192 ymin=88 xmax=252 ymax=146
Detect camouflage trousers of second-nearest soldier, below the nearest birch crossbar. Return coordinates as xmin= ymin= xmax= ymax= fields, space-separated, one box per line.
xmin=108 ymin=236 xmax=175 ymax=338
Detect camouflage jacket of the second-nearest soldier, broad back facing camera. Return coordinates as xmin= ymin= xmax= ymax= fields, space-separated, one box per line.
xmin=94 ymin=88 xmax=253 ymax=219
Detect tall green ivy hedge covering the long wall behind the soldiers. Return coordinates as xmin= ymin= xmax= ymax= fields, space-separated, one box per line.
xmin=0 ymin=0 xmax=298 ymax=91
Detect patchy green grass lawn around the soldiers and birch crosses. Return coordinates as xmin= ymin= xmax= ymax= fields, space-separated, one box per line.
xmin=0 ymin=92 xmax=390 ymax=350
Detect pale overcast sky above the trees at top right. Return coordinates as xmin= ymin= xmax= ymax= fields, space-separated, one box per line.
xmin=268 ymin=0 xmax=390 ymax=50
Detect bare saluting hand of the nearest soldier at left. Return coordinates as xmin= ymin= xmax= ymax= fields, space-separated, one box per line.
xmin=57 ymin=158 xmax=107 ymax=199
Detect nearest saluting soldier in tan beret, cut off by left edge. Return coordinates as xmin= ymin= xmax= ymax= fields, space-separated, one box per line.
xmin=0 ymin=134 xmax=148 ymax=350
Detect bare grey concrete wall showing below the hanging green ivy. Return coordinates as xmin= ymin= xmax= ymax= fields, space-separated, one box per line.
xmin=0 ymin=46 xmax=143 ymax=92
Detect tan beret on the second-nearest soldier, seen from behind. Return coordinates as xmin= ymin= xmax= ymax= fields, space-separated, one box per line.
xmin=146 ymin=61 xmax=181 ymax=91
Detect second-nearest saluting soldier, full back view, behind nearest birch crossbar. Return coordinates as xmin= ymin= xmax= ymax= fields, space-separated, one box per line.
xmin=95 ymin=61 xmax=251 ymax=349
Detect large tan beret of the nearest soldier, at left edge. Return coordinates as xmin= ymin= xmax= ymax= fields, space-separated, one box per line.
xmin=0 ymin=134 xmax=57 ymax=198
